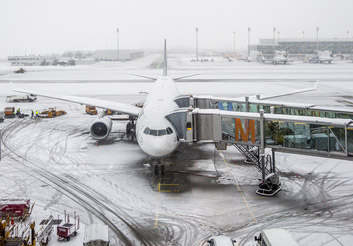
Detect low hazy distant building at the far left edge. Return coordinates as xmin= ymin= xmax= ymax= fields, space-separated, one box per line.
xmin=8 ymin=55 xmax=57 ymax=66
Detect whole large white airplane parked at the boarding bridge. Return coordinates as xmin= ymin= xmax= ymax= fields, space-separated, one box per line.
xmin=13 ymin=40 xmax=317 ymax=171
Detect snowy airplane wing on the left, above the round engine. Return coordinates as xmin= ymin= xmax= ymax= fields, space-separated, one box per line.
xmin=12 ymin=88 xmax=141 ymax=116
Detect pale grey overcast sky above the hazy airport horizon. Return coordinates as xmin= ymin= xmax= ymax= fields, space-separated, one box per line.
xmin=0 ymin=0 xmax=353 ymax=57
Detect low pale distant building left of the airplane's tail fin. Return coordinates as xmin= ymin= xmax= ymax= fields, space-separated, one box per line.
xmin=91 ymin=50 xmax=144 ymax=61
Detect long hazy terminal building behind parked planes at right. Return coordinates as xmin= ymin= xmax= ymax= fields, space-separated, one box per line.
xmin=251 ymin=38 xmax=353 ymax=56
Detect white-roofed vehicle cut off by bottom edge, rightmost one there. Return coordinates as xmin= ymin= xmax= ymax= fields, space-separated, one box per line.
xmin=255 ymin=228 xmax=298 ymax=246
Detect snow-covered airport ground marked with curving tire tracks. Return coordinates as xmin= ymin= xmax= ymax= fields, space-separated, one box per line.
xmin=0 ymin=55 xmax=353 ymax=246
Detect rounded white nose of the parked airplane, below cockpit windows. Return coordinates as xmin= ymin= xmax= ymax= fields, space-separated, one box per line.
xmin=140 ymin=135 xmax=178 ymax=158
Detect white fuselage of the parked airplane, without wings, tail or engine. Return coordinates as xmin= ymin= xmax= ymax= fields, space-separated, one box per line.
xmin=136 ymin=76 xmax=179 ymax=158
